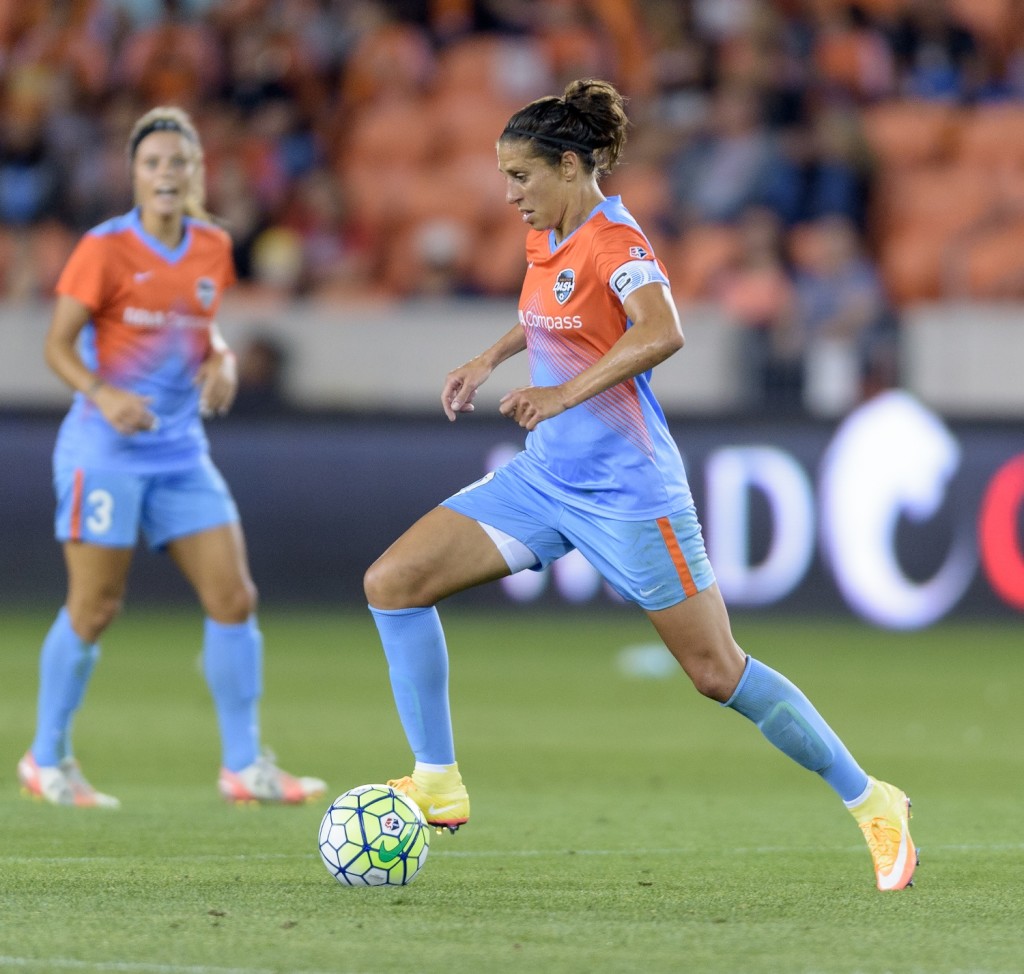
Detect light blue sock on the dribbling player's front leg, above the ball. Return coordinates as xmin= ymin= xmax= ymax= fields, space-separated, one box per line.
xmin=370 ymin=605 xmax=455 ymax=765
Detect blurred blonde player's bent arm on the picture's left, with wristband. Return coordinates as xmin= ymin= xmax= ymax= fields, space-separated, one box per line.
xmin=44 ymin=294 xmax=156 ymax=434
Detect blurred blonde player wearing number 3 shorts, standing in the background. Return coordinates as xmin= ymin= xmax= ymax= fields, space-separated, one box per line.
xmin=17 ymin=108 xmax=325 ymax=807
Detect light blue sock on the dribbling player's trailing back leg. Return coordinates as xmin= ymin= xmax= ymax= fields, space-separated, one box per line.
xmin=722 ymin=657 xmax=867 ymax=802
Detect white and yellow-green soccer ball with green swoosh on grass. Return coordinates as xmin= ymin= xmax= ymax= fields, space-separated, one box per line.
xmin=319 ymin=785 xmax=430 ymax=886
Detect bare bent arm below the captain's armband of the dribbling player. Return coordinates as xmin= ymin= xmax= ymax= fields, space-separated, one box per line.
xmin=500 ymin=282 xmax=683 ymax=429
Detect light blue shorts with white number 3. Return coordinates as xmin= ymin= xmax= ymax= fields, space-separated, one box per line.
xmin=53 ymin=457 xmax=239 ymax=549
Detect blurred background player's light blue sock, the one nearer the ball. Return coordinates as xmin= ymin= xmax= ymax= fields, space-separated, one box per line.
xmin=203 ymin=616 xmax=263 ymax=771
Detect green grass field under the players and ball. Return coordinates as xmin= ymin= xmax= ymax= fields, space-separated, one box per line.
xmin=0 ymin=608 xmax=1024 ymax=974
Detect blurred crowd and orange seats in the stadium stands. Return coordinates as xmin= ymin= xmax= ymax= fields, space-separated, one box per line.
xmin=0 ymin=0 xmax=1024 ymax=403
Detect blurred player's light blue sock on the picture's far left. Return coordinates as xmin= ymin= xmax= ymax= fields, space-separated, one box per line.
xmin=31 ymin=608 xmax=99 ymax=767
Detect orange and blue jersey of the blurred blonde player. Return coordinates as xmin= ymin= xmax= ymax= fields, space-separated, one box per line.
xmin=56 ymin=210 xmax=236 ymax=473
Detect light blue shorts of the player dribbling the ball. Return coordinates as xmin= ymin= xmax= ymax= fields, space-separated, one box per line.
xmin=442 ymin=467 xmax=715 ymax=611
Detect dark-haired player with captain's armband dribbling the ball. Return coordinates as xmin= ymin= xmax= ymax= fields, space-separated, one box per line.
xmin=365 ymin=81 xmax=916 ymax=889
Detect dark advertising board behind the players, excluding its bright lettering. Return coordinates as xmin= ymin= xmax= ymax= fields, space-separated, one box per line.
xmin=0 ymin=407 xmax=1024 ymax=621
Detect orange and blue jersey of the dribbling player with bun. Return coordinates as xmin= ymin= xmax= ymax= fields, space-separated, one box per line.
xmin=515 ymin=197 xmax=692 ymax=520
